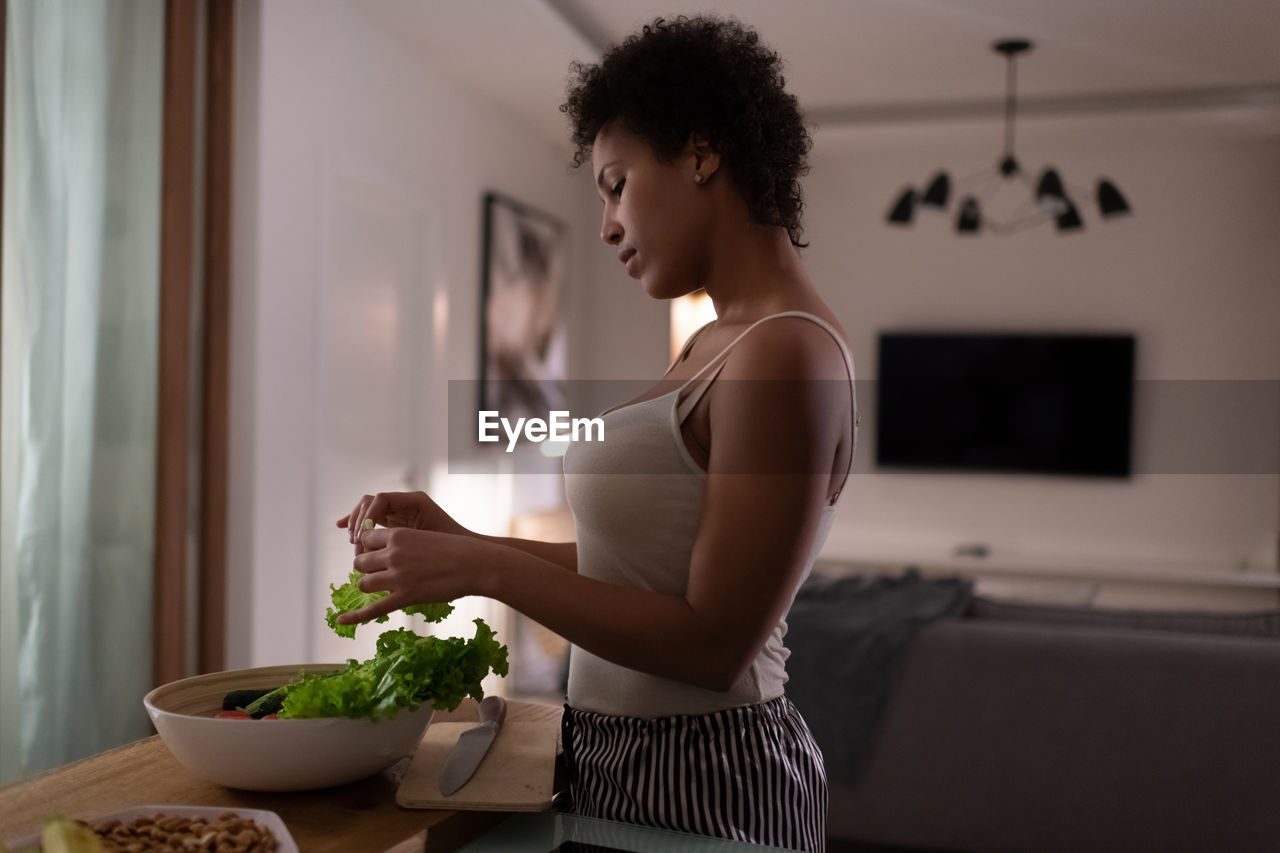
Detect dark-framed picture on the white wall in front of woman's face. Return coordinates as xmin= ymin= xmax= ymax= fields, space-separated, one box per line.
xmin=480 ymin=192 xmax=568 ymax=423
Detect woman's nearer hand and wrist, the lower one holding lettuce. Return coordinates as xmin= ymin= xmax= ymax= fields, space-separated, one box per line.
xmin=338 ymin=528 xmax=486 ymax=625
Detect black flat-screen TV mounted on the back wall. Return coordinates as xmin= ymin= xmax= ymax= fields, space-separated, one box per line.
xmin=876 ymin=332 xmax=1134 ymax=478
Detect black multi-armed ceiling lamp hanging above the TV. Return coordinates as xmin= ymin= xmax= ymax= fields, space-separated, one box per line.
xmin=887 ymin=38 xmax=1130 ymax=234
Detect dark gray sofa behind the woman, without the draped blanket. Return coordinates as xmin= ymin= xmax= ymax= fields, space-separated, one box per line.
xmin=801 ymin=573 xmax=1280 ymax=853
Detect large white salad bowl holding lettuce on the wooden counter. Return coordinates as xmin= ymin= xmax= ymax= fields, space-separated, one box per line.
xmin=142 ymin=663 xmax=434 ymax=790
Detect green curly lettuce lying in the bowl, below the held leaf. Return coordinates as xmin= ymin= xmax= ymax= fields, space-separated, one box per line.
xmin=259 ymin=619 xmax=507 ymax=721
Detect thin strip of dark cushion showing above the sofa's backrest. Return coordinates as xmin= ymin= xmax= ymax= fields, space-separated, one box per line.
xmin=965 ymin=596 xmax=1280 ymax=637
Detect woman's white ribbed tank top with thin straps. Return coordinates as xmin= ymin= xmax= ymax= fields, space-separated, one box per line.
xmin=564 ymin=311 xmax=858 ymax=719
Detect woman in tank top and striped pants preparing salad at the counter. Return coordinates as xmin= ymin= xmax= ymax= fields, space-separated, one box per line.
xmin=338 ymin=18 xmax=856 ymax=849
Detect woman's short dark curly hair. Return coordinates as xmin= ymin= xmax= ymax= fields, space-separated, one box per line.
xmin=561 ymin=15 xmax=813 ymax=246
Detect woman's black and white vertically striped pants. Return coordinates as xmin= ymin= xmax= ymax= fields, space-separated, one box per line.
xmin=562 ymin=695 xmax=827 ymax=852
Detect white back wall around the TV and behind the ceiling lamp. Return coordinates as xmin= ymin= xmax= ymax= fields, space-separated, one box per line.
xmin=806 ymin=120 xmax=1280 ymax=584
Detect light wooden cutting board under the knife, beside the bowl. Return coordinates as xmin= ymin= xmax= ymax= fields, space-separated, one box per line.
xmin=396 ymin=719 xmax=559 ymax=812
